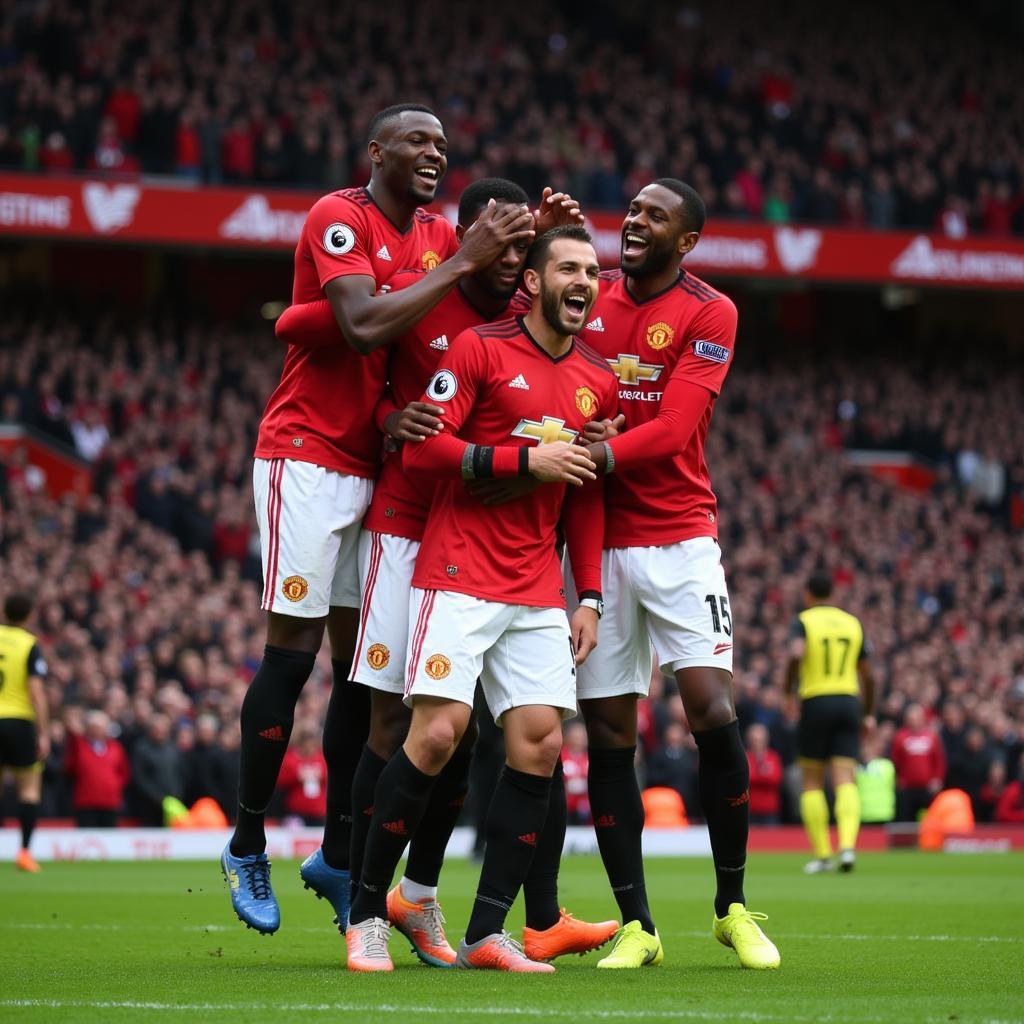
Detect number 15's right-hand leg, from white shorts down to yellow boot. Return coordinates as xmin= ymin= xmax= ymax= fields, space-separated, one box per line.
xmin=643 ymin=537 xmax=779 ymax=969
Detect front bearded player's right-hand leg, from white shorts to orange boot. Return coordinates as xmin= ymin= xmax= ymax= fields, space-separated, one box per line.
xmin=458 ymin=608 xmax=575 ymax=972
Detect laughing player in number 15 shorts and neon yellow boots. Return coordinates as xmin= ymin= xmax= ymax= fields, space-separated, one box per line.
xmin=579 ymin=178 xmax=779 ymax=969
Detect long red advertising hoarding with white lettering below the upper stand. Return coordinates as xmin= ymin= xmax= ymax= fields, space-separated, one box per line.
xmin=0 ymin=174 xmax=1024 ymax=290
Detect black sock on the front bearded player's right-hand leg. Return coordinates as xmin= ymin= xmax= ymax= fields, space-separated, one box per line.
xmin=466 ymin=765 xmax=551 ymax=944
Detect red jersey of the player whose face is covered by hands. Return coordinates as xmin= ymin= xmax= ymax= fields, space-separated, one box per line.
xmin=362 ymin=270 xmax=508 ymax=541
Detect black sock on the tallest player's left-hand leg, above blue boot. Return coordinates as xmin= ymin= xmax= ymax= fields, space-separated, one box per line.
xmin=231 ymin=644 xmax=315 ymax=857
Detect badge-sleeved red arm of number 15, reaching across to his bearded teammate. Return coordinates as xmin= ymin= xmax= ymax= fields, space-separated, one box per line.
xmin=589 ymin=299 xmax=736 ymax=473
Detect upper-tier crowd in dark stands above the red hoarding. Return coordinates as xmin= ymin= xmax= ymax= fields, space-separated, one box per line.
xmin=0 ymin=0 xmax=1024 ymax=237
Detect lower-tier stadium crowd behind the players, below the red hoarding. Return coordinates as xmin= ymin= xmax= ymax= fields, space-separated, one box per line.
xmin=0 ymin=303 xmax=1024 ymax=823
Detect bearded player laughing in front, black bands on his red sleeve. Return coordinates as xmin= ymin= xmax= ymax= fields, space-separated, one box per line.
xmin=346 ymin=226 xmax=616 ymax=971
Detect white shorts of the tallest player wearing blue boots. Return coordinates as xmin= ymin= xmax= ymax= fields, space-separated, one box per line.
xmin=253 ymin=459 xmax=374 ymax=618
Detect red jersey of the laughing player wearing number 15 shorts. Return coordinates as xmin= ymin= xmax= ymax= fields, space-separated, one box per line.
xmin=582 ymin=270 xmax=736 ymax=548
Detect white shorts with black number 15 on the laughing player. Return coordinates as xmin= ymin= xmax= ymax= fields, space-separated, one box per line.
xmin=566 ymin=537 xmax=732 ymax=700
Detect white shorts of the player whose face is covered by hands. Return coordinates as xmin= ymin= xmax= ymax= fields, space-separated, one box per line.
xmin=352 ymin=529 xmax=420 ymax=694
